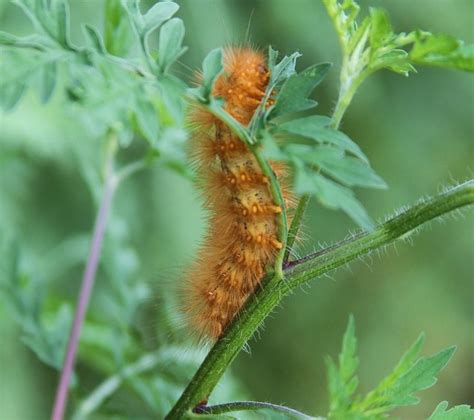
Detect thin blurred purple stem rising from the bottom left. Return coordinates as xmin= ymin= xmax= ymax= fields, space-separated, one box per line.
xmin=51 ymin=166 xmax=117 ymax=420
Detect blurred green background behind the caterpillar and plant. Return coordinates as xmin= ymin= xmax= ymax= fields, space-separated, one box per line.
xmin=0 ymin=0 xmax=474 ymax=420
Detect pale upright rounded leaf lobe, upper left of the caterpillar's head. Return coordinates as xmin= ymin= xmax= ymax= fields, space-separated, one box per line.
xmin=157 ymin=18 xmax=187 ymax=72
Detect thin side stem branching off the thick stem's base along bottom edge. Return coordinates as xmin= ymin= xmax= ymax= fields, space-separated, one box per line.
xmin=194 ymin=401 xmax=324 ymax=420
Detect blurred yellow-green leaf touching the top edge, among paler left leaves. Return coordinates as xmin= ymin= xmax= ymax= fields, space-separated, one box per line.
xmin=104 ymin=0 xmax=134 ymax=56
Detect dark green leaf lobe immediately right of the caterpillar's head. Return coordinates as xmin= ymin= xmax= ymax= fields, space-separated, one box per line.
xmin=270 ymin=63 xmax=331 ymax=117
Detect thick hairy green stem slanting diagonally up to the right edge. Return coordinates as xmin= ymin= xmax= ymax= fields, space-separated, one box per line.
xmin=166 ymin=180 xmax=474 ymax=419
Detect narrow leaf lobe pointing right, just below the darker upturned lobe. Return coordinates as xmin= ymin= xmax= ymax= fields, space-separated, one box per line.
xmin=277 ymin=115 xmax=367 ymax=162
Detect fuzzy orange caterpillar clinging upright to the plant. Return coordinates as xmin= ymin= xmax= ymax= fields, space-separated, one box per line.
xmin=184 ymin=48 xmax=289 ymax=339
